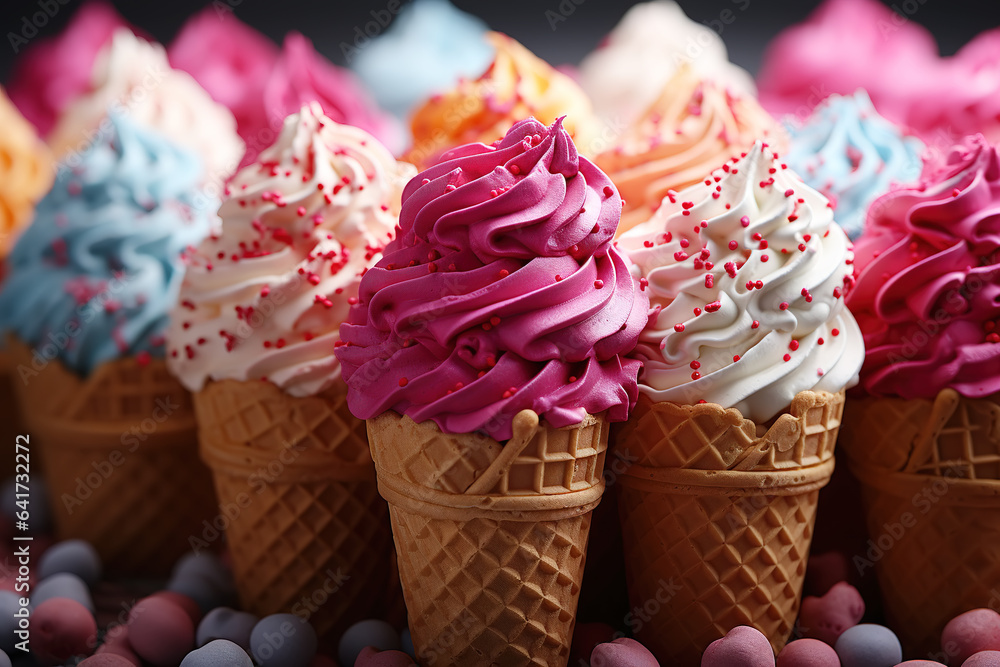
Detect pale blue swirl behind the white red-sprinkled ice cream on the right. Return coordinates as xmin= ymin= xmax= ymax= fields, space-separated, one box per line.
xmin=785 ymin=90 xmax=924 ymax=239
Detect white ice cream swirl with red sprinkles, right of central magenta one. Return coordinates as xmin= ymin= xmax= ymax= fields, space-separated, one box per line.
xmin=619 ymin=142 xmax=864 ymax=422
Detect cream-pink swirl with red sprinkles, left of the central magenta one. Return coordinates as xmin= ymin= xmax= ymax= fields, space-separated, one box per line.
xmin=167 ymin=102 xmax=416 ymax=396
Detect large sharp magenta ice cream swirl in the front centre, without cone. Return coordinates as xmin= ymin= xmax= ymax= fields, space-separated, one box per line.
xmin=337 ymin=118 xmax=648 ymax=440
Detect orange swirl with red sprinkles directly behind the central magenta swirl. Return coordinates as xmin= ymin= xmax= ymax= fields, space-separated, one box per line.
xmin=405 ymin=32 xmax=596 ymax=169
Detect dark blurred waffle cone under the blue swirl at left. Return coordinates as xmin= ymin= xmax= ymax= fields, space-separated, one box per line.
xmin=9 ymin=341 xmax=214 ymax=575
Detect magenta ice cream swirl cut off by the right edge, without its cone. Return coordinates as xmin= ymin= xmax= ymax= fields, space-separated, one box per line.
xmin=847 ymin=135 xmax=1000 ymax=398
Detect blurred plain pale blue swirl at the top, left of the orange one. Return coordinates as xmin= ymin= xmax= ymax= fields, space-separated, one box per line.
xmin=346 ymin=0 xmax=493 ymax=118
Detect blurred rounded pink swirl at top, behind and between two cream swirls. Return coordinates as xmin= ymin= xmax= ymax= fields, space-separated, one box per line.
xmin=167 ymin=7 xmax=278 ymax=165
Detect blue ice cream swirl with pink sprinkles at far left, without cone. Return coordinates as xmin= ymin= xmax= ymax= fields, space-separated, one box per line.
xmin=0 ymin=115 xmax=219 ymax=376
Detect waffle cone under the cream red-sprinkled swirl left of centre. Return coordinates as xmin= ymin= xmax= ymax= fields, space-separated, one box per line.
xmin=195 ymin=380 xmax=392 ymax=641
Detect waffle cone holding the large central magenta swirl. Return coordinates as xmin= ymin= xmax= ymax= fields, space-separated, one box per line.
xmin=368 ymin=410 xmax=608 ymax=667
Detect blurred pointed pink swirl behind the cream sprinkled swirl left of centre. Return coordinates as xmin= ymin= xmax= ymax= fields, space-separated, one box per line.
xmin=264 ymin=32 xmax=403 ymax=159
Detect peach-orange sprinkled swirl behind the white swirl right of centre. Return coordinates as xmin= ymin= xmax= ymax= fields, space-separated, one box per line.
xmin=595 ymin=66 xmax=787 ymax=234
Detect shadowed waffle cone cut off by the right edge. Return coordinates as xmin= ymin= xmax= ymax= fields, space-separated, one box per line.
xmin=842 ymin=389 xmax=1000 ymax=655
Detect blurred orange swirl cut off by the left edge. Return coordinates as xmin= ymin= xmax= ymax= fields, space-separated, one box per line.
xmin=0 ymin=89 xmax=53 ymax=261
